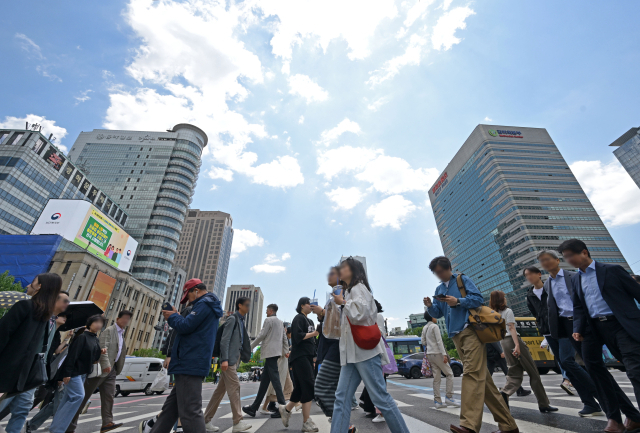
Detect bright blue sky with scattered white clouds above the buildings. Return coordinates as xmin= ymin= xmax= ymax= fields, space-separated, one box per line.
xmin=0 ymin=0 xmax=640 ymax=326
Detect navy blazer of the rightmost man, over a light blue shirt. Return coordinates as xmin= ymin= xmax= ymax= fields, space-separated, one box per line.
xmin=571 ymin=262 xmax=640 ymax=342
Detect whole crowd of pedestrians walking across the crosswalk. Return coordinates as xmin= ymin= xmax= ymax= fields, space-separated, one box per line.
xmin=0 ymin=239 xmax=640 ymax=433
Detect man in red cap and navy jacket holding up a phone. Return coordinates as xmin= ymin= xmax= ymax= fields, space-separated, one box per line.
xmin=142 ymin=278 xmax=222 ymax=433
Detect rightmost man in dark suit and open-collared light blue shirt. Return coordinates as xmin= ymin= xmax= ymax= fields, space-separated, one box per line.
xmin=558 ymin=239 xmax=640 ymax=433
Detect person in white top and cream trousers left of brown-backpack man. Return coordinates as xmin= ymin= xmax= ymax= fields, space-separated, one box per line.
xmin=422 ymin=311 xmax=460 ymax=409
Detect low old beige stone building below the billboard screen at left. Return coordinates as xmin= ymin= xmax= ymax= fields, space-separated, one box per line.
xmin=49 ymin=239 xmax=163 ymax=355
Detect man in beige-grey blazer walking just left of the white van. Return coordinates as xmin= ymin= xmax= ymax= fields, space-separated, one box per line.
xmin=67 ymin=310 xmax=133 ymax=433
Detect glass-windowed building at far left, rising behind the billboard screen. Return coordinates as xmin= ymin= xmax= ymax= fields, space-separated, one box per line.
xmin=0 ymin=124 xmax=128 ymax=234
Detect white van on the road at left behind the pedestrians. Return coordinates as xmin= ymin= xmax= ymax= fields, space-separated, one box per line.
xmin=116 ymin=356 xmax=164 ymax=397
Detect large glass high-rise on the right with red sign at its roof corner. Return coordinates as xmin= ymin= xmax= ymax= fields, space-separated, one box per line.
xmin=429 ymin=125 xmax=631 ymax=316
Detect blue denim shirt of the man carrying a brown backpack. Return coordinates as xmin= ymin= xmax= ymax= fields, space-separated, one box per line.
xmin=427 ymin=274 xmax=484 ymax=337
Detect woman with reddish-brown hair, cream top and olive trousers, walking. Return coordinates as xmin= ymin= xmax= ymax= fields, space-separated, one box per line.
xmin=489 ymin=290 xmax=558 ymax=413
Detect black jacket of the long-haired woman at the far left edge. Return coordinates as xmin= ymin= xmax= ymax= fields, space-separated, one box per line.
xmin=0 ymin=299 xmax=49 ymax=392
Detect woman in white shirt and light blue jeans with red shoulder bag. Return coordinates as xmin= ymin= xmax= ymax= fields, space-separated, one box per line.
xmin=331 ymin=257 xmax=409 ymax=433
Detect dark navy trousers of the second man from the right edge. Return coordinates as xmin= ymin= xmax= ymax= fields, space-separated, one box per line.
xmin=546 ymin=336 xmax=601 ymax=411
